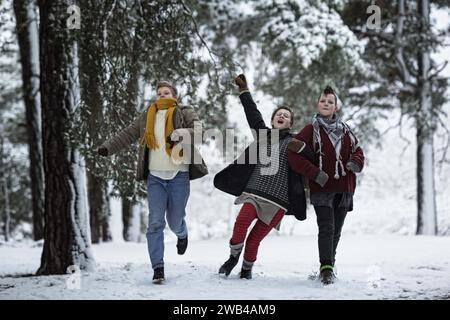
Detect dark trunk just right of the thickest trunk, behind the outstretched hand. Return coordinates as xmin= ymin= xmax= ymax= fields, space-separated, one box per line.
xmin=80 ymin=1 xmax=112 ymax=243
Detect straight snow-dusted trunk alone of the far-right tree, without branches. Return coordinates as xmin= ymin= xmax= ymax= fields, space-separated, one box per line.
xmin=416 ymin=0 xmax=437 ymax=235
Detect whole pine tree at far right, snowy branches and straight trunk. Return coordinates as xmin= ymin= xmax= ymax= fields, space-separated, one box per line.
xmin=342 ymin=0 xmax=448 ymax=235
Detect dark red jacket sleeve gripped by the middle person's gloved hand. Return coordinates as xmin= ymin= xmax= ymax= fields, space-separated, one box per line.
xmin=288 ymin=124 xmax=320 ymax=179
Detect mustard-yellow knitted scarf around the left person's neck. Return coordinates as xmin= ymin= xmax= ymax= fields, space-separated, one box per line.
xmin=141 ymin=98 xmax=177 ymax=156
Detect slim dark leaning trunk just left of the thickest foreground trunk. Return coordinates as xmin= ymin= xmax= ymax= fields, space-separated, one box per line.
xmin=14 ymin=0 xmax=44 ymax=240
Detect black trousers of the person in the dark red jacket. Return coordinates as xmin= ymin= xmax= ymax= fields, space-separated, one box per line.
xmin=314 ymin=193 xmax=348 ymax=266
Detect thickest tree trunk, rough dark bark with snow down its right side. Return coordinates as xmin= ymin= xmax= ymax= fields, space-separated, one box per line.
xmin=37 ymin=0 xmax=94 ymax=274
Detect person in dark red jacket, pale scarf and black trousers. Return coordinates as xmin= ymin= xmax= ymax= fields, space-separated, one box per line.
xmin=288 ymin=87 xmax=364 ymax=284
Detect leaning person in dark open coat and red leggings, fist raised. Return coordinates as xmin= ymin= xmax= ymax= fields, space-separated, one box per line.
xmin=214 ymin=75 xmax=313 ymax=279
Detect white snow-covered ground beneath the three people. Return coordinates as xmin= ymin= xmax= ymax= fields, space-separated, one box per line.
xmin=0 ymin=232 xmax=450 ymax=300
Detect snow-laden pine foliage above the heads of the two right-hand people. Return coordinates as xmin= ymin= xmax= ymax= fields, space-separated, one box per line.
xmin=193 ymin=0 xmax=373 ymax=135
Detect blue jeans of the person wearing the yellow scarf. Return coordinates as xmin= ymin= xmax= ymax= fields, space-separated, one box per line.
xmin=147 ymin=171 xmax=190 ymax=269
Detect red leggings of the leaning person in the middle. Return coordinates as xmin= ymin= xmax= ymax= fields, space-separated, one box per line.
xmin=231 ymin=203 xmax=284 ymax=262
